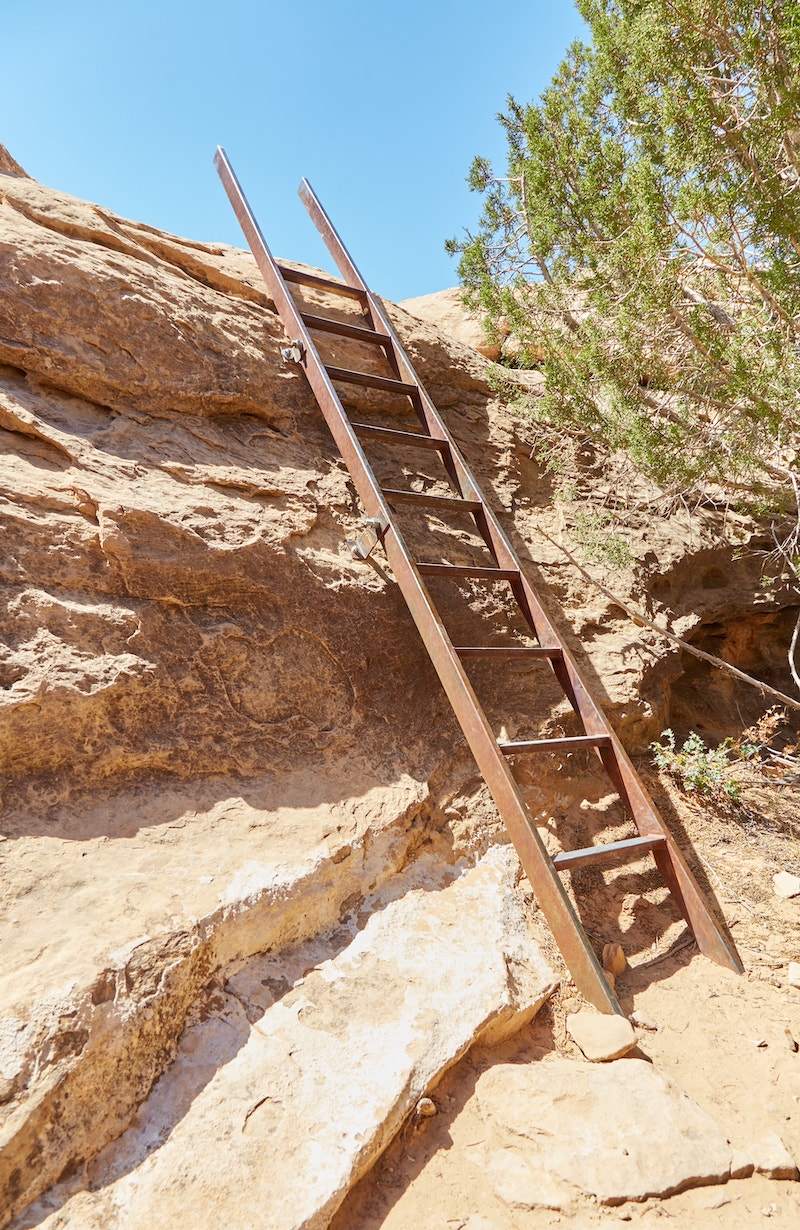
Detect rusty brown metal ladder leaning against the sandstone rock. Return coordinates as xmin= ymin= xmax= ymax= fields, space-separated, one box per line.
xmin=214 ymin=149 xmax=742 ymax=1014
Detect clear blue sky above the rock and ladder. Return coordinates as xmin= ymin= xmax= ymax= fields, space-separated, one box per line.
xmin=0 ymin=0 xmax=582 ymax=300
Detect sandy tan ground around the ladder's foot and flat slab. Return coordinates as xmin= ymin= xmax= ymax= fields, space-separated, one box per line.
xmin=332 ymin=772 xmax=800 ymax=1230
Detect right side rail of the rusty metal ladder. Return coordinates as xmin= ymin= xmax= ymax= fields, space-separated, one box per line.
xmin=300 ymin=180 xmax=742 ymax=972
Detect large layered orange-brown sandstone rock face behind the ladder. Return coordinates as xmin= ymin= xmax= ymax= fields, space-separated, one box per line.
xmin=0 ymin=153 xmax=788 ymax=1218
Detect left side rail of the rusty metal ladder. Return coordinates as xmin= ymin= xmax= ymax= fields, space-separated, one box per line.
xmin=215 ymin=150 xmax=622 ymax=1014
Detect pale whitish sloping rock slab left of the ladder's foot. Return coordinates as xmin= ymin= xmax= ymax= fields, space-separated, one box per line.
xmin=31 ymin=847 xmax=555 ymax=1230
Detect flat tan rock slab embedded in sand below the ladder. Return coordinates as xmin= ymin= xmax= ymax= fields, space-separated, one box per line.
xmin=476 ymin=1058 xmax=731 ymax=1208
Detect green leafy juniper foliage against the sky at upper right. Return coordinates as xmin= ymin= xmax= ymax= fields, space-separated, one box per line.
xmin=448 ymin=0 xmax=800 ymax=499
